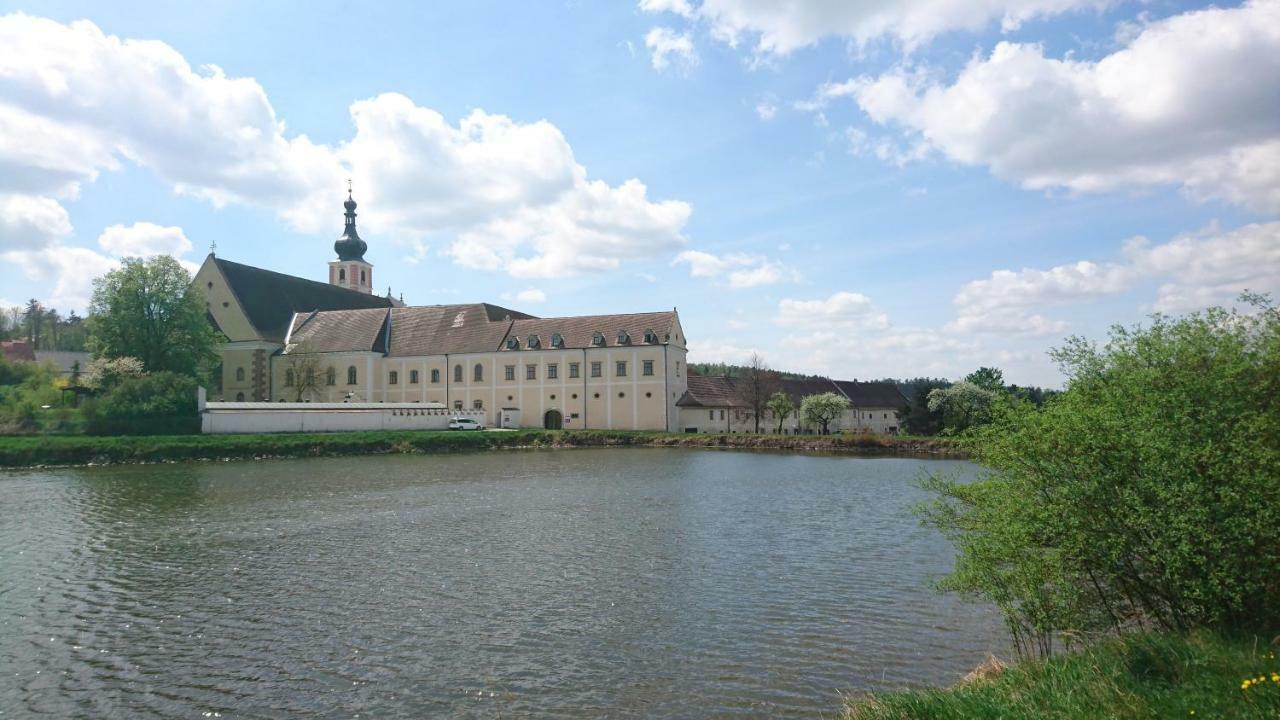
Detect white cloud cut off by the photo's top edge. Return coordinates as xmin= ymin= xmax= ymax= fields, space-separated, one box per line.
xmin=640 ymin=0 xmax=1110 ymax=55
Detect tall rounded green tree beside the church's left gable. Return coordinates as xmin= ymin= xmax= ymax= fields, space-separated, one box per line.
xmin=88 ymin=255 xmax=219 ymax=377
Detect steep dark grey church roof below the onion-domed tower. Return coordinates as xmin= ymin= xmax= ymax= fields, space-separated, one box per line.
xmin=214 ymin=258 xmax=392 ymax=342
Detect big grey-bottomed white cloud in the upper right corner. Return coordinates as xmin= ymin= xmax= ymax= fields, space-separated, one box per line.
xmin=834 ymin=0 xmax=1280 ymax=211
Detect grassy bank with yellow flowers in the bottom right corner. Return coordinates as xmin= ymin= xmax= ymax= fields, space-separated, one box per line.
xmin=845 ymin=633 xmax=1280 ymax=720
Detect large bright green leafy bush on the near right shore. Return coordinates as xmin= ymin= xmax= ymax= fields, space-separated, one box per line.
xmin=923 ymin=299 xmax=1280 ymax=652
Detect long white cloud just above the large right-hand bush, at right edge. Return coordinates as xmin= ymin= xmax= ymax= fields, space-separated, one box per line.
xmin=946 ymin=222 xmax=1280 ymax=336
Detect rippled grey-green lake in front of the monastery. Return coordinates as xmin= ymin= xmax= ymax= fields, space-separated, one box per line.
xmin=0 ymin=448 xmax=1007 ymax=719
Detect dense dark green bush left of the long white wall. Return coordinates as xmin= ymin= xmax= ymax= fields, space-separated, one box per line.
xmin=84 ymin=373 xmax=200 ymax=434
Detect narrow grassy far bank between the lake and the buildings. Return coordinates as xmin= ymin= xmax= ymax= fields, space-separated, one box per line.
xmin=0 ymin=429 xmax=964 ymax=468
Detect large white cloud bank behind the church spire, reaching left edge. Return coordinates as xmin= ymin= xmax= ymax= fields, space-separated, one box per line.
xmin=0 ymin=14 xmax=691 ymax=277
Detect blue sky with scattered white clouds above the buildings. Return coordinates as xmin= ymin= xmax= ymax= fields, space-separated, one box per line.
xmin=0 ymin=0 xmax=1280 ymax=387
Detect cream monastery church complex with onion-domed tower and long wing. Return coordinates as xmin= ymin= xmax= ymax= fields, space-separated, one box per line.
xmin=193 ymin=191 xmax=689 ymax=432
